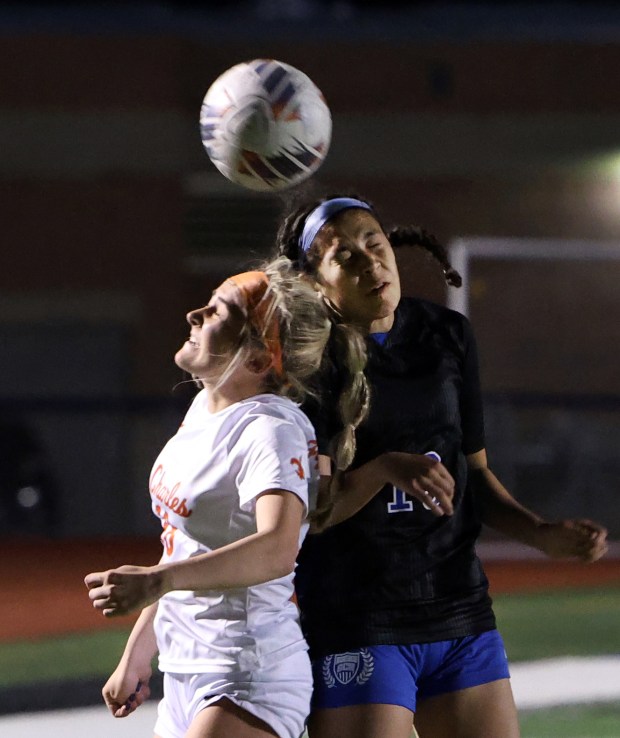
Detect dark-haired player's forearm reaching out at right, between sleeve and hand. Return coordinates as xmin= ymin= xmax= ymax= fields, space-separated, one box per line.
xmin=470 ymin=468 xmax=545 ymax=549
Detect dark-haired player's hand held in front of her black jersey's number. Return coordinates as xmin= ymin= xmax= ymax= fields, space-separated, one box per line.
xmin=384 ymin=451 xmax=454 ymax=517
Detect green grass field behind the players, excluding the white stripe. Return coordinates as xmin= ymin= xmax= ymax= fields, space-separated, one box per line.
xmin=0 ymin=587 xmax=620 ymax=738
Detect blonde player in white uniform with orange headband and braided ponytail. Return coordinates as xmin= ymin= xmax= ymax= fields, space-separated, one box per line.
xmin=85 ymin=259 xmax=367 ymax=738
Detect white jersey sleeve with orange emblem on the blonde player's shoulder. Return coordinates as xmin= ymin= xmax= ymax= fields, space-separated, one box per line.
xmin=236 ymin=416 xmax=310 ymax=511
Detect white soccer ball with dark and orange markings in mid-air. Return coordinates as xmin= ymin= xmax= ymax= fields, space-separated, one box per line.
xmin=200 ymin=59 xmax=332 ymax=192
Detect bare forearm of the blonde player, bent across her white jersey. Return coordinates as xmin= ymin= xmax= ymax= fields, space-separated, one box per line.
xmin=156 ymin=530 xmax=298 ymax=592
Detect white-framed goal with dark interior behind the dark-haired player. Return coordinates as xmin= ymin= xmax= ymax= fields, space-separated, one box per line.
xmin=446 ymin=237 xmax=620 ymax=539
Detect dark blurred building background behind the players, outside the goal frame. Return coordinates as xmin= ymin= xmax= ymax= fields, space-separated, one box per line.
xmin=0 ymin=0 xmax=620 ymax=537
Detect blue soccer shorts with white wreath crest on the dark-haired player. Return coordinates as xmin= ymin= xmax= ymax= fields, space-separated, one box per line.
xmin=312 ymin=630 xmax=510 ymax=712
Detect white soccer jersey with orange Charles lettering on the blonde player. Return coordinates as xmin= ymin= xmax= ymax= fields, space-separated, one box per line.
xmin=150 ymin=390 xmax=318 ymax=674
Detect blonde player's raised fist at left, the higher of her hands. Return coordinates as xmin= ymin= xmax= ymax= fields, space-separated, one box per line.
xmin=84 ymin=566 xmax=168 ymax=617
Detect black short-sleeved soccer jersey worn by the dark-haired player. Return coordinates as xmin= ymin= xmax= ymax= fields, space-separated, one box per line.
xmin=296 ymin=298 xmax=495 ymax=658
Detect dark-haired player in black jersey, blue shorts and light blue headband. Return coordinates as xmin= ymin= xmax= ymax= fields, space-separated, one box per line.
xmin=278 ymin=195 xmax=606 ymax=738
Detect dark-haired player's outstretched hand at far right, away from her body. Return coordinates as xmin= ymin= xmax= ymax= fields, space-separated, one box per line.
xmin=538 ymin=519 xmax=607 ymax=563
